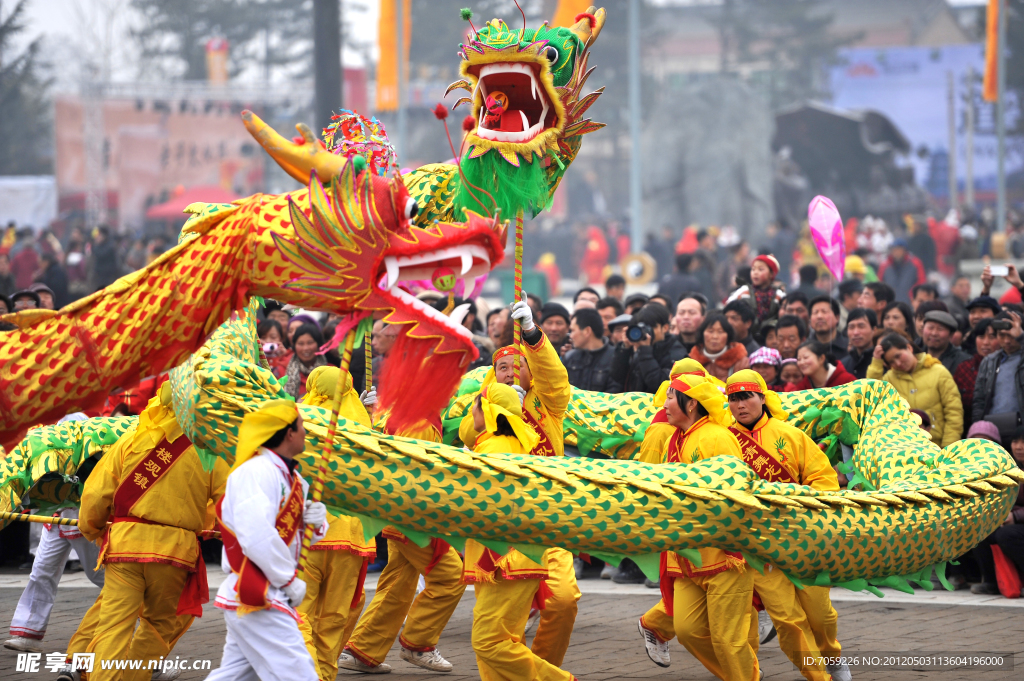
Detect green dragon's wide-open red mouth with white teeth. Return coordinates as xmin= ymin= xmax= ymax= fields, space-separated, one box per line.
xmin=473 ymin=61 xmax=556 ymax=143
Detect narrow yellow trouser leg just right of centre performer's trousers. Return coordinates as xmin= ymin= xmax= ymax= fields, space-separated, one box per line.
xmin=530 ymin=549 xmax=582 ymax=667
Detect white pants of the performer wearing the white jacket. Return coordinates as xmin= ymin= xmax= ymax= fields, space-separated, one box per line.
xmin=206 ymin=609 xmax=318 ymax=681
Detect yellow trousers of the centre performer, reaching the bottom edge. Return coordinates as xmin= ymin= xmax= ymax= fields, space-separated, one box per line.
xmin=473 ymin=580 xmax=573 ymax=681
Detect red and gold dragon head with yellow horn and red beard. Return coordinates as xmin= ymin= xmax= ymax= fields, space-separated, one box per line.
xmin=245 ymin=112 xmax=508 ymax=428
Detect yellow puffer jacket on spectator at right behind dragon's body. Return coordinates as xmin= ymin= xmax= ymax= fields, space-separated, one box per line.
xmin=867 ymin=352 xmax=964 ymax=446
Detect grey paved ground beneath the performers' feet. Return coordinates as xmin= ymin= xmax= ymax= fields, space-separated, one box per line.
xmin=0 ymin=570 xmax=1024 ymax=681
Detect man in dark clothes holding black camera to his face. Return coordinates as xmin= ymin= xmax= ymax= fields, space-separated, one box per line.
xmin=608 ymin=303 xmax=688 ymax=393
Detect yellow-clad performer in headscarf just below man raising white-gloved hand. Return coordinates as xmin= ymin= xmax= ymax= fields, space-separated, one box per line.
xmin=463 ymin=383 xmax=574 ymax=681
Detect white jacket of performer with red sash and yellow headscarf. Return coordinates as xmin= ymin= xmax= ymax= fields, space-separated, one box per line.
xmin=214 ymin=448 xmax=328 ymax=616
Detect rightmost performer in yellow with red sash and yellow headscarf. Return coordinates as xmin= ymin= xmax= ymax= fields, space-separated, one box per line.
xmin=725 ymin=369 xmax=850 ymax=681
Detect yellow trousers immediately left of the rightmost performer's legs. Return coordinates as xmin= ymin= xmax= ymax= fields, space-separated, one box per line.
xmin=671 ymin=569 xmax=759 ymax=681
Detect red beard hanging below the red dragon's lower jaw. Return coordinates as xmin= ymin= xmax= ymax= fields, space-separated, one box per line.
xmin=380 ymin=333 xmax=464 ymax=434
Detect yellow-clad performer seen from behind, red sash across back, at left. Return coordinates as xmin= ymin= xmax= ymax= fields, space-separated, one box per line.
xmin=75 ymin=384 xmax=226 ymax=681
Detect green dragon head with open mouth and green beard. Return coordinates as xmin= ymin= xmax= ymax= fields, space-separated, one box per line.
xmin=449 ymin=7 xmax=604 ymax=217
